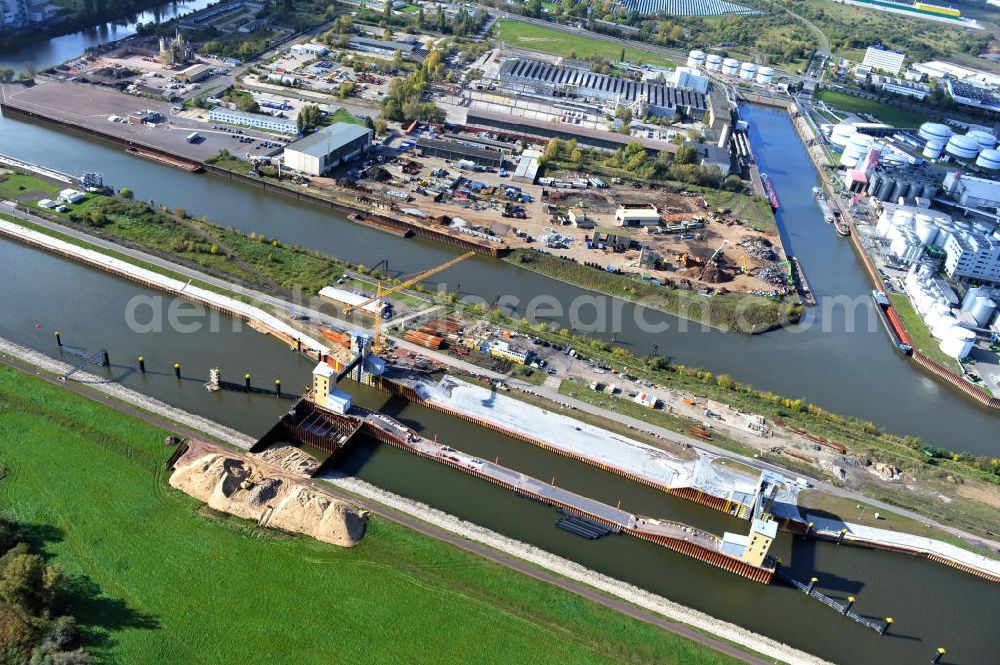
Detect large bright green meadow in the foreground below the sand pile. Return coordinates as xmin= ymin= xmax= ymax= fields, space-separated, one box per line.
xmin=0 ymin=367 xmax=752 ymax=665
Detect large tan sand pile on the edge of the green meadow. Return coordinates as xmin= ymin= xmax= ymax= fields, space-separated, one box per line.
xmin=170 ymin=453 xmax=368 ymax=547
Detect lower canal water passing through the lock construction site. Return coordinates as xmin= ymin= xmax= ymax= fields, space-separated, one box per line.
xmin=0 ymin=240 xmax=1000 ymax=665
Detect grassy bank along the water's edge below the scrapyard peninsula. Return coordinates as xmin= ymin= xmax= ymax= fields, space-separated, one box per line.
xmin=505 ymin=250 xmax=802 ymax=333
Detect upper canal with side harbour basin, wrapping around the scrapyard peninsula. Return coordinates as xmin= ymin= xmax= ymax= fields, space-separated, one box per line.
xmin=0 ymin=107 xmax=1000 ymax=455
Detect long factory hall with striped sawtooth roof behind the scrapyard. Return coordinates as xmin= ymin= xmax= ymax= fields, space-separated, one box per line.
xmin=499 ymin=58 xmax=708 ymax=120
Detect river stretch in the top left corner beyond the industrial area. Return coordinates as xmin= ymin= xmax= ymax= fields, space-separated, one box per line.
xmin=0 ymin=0 xmax=216 ymax=70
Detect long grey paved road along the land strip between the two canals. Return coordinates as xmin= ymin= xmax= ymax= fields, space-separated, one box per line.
xmin=0 ymin=203 xmax=1000 ymax=551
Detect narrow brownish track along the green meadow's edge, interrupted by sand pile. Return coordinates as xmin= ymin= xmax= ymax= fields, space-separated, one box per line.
xmin=0 ymin=348 xmax=772 ymax=665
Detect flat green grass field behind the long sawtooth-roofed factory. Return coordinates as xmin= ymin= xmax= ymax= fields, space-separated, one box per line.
xmin=497 ymin=20 xmax=677 ymax=67
